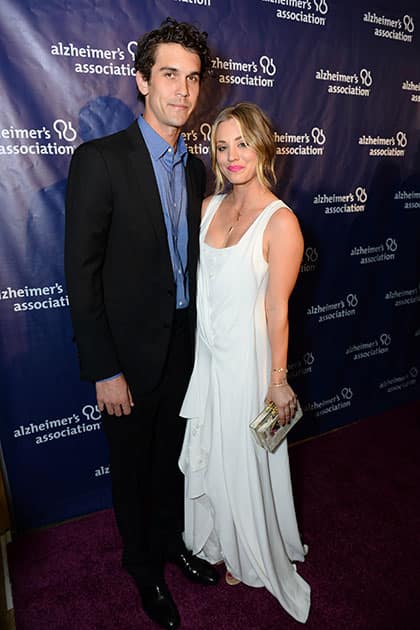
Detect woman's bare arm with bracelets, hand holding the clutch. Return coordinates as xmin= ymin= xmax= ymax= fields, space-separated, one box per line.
xmin=264 ymin=209 xmax=303 ymax=424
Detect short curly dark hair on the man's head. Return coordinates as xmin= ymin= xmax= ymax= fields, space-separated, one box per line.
xmin=134 ymin=17 xmax=211 ymax=98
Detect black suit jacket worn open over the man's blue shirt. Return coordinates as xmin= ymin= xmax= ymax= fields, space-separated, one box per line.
xmin=65 ymin=121 xmax=205 ymax=394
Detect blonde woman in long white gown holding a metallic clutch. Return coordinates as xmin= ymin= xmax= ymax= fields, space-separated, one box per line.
xmin=180 ymin=103 xmax=310 ymax=622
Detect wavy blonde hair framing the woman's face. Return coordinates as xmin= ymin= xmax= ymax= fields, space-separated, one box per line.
xmin=211 ymin=103 xmax=277 ymax=194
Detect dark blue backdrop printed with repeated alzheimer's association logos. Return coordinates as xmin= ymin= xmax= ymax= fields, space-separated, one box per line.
xmin=0 ymin=0 xmax=420 ymax=530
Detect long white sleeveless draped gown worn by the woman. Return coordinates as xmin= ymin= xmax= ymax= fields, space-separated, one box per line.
xmin=179 ymin=195 xmax=310 ymax=622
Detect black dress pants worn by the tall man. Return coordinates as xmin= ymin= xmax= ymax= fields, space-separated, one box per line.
xmin=102 ymin=309 xmax=193 ymax=585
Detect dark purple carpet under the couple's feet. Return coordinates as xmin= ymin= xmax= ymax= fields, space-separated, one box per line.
xmin=9 ymin=403 xmax=420 ymax=630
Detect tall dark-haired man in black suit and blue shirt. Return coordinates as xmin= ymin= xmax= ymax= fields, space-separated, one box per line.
xmin=65 ymin=18 xmax=218 ymax=628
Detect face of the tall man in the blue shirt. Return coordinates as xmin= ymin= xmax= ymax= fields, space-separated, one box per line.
xmin=136 ymin=44 xmax=201 ymax=138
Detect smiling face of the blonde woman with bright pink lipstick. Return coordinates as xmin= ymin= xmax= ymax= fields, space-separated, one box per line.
xmin=216 ymin=118 xmax=257 ymax=185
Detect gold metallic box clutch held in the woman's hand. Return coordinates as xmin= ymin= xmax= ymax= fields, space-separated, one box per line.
xmin=249 ymin=401 xmax=303 ymax=453
